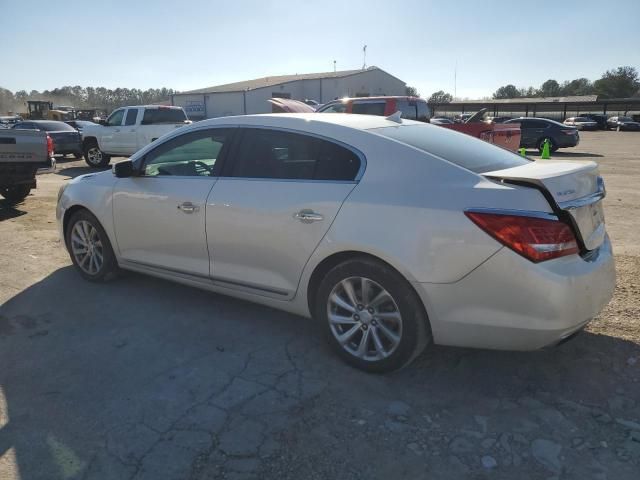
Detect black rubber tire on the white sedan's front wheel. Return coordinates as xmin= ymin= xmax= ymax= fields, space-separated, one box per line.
xmin=64 ymin=210 xmax=118 ymax=282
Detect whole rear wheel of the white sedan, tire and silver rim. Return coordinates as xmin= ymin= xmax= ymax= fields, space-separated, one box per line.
xmin=315 ymin=258 xmax=431 ymax=373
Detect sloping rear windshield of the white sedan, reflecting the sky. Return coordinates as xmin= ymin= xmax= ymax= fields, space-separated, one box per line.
xmin=369 ymin=123 xmax=529 ymax=173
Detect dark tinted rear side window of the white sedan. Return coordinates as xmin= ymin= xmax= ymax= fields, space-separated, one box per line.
xmin=231 ymin=129 xmax=360 ymax=181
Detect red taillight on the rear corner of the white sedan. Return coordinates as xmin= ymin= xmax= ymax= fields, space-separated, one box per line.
xmin=465 ymin=211 xmax=578 ymax=262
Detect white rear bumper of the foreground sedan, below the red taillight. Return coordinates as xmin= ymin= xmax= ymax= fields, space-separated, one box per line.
xmin=414 ymin=237 xmax=615 ymax=350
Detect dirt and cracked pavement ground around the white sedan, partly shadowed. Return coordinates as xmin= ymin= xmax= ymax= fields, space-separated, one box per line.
xmin=0 ymin=132 xmax=640 ymax=480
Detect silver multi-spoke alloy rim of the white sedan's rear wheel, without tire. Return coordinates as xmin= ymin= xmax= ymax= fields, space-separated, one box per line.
xmin=327 ymin=277 xmax=402 ymax=361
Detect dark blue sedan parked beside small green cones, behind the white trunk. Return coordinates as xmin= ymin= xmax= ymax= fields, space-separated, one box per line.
xmin=504 ymin=117 xmax=580 ymax=152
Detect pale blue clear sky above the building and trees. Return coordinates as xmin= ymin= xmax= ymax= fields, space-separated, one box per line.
xmin=0 ymin=0 xmax=640 ymax=98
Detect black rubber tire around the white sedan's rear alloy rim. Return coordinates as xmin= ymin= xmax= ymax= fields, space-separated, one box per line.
xmin=314 ymin=257 xmax=431 ymax=373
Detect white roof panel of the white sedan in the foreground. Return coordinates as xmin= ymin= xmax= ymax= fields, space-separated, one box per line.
xmin=193 ymin=113 xmax=421 ymax=130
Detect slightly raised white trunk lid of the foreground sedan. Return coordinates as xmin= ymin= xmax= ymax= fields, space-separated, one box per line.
xmin=484 ymin=160 xmax=606 ymax=250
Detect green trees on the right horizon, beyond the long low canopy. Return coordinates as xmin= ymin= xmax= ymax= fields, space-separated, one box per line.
xmin=422 ymin=66 xmax=640 ymax=104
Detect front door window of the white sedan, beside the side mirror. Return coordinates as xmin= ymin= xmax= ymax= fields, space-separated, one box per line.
xmin=144 ymin=128 xmax=231 ymax=177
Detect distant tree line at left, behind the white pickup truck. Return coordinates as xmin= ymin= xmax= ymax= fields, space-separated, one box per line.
xmin=0 ymin=85 xmax=177 ymax=114
